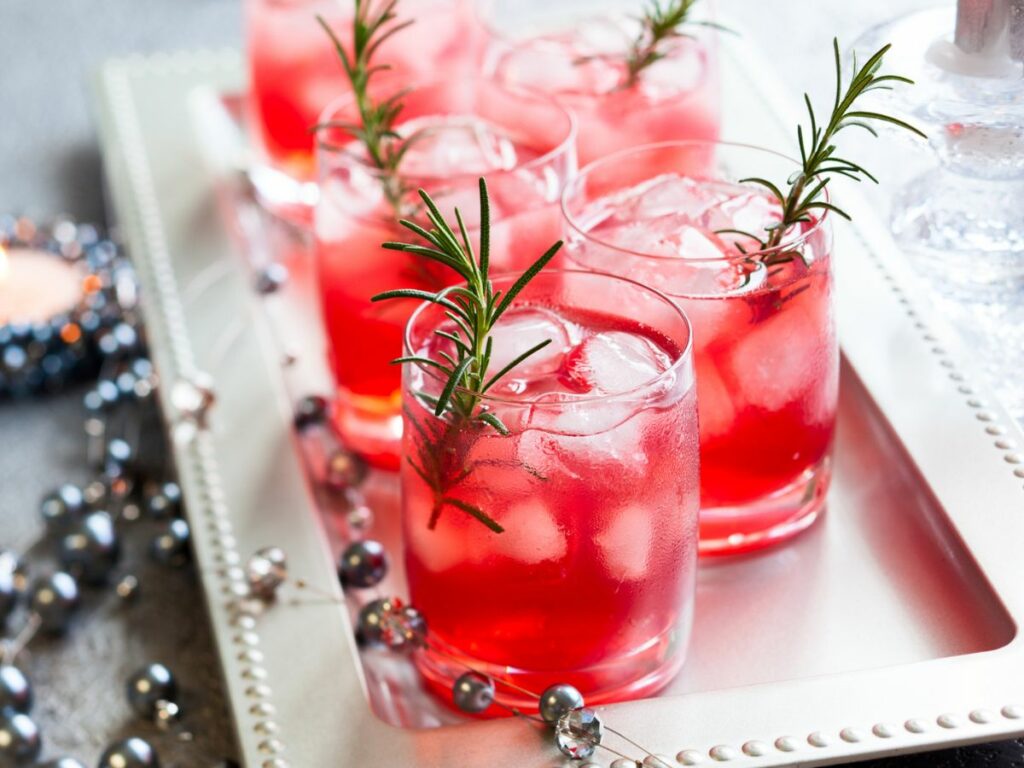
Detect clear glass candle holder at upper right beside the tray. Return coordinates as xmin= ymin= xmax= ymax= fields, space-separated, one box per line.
xmin=854 ymin=0 xmax=1024 ymax=303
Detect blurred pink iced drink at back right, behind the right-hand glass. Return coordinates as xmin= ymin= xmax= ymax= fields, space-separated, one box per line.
xmin=484 ymin=0 xmax=721 ymax=165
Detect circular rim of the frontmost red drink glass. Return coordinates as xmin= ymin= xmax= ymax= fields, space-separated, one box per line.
xmin=402 ymin=269 xmax=695 ymax=413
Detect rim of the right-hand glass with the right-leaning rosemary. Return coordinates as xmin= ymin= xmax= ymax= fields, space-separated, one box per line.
xmin=560 ymin=139 xmax=829 ymax=264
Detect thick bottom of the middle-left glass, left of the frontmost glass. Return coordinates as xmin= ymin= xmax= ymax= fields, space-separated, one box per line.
xmin=331 ymin=392 xmax=401 ymax=472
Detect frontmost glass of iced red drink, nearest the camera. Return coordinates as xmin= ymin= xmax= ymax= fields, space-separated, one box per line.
xmin=401 ymin=272 xmax=699 ymax=709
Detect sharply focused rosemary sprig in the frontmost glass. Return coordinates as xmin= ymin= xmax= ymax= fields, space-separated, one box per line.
xmin=373 ymin=178 xmax=562 ymax=534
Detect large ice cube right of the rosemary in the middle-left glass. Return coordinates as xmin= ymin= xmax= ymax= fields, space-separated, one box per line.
xmin=400 ymin=115 xmax=516 ymax=176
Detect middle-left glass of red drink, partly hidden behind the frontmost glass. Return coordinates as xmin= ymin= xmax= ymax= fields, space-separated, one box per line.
xmin=314 ymin=80 xmax=575 ymax=469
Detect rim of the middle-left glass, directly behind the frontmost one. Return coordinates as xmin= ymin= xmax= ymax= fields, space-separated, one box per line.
xmin=313 ymin=74 xmax=579 ymax=186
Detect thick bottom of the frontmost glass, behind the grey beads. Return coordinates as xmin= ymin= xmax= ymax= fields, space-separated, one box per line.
xmin=416 ymin=614 xmax=693 ymax=717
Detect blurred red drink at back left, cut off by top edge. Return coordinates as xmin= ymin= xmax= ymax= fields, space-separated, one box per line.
xmin=246 ymin=0 xmax=483 ymax=215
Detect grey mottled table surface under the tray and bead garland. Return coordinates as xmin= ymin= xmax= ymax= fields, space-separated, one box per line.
xmin=0 ymin=0 xmax=1024 ymax=768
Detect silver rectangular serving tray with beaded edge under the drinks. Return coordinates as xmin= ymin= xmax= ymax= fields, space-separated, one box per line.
xmin=92 ymin=27 xmax=1024 ymax=768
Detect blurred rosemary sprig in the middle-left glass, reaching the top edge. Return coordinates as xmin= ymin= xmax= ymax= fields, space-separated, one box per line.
xmin=316 ymin=0 xmax=414 ymax=214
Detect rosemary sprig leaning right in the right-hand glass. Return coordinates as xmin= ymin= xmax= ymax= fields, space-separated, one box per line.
xmin=733 ymin=38 xmax=927 ymax=256
